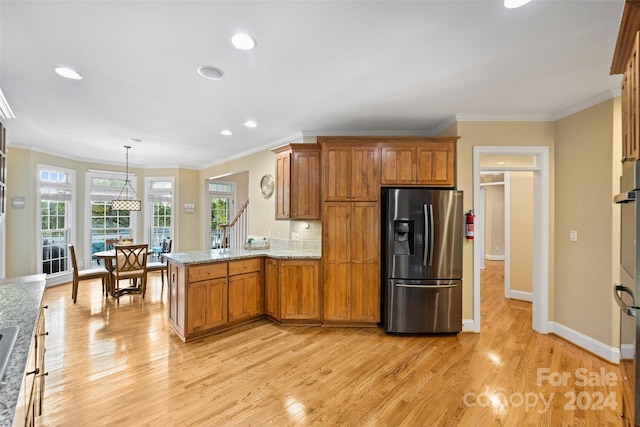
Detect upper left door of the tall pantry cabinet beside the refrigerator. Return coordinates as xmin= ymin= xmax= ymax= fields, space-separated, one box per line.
xmin=322 ymin=145 xmax=351 ymax=201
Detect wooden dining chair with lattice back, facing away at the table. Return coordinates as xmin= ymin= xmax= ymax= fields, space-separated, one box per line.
xmin=112 ymin=243 xmax=149 ymax=302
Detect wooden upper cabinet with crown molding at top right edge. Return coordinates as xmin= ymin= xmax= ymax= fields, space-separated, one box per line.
xmin=611 ymin=1 xmax=640 ymax=168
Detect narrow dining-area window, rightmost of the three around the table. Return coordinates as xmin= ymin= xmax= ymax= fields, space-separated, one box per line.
xmin=145 ymin=177 xmax=175 ymax=257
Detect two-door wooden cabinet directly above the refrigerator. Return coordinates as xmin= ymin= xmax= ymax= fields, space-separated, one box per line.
xmin=380 ymin=137 xmax=457 ymax=188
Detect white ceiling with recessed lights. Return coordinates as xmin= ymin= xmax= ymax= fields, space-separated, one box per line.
xmin=0 ymin=0 xmax=624 ymax=169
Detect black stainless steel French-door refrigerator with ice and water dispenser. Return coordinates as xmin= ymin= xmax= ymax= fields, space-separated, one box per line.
xmin=381 ymin=188 xmax=464 ymax=334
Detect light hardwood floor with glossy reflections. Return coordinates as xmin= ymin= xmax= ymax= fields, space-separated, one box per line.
xmin=39 ymin=262 xmax=622 ymax=426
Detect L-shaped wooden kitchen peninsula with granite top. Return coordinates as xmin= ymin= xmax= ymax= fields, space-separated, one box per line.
xmin=166 ymin=248 xmax=321 ymax=341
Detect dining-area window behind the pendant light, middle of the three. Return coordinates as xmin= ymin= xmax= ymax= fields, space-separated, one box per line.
xmin=86 ymin=171 xmax=136 ymax=267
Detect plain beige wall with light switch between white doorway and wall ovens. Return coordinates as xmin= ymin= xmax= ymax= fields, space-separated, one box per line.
xmin=554 ymin=100 xmax=621 ymax=345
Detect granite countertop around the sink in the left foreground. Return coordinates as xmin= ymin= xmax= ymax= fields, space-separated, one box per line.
xmin=0 ymin=274 xmax=47 ymax=427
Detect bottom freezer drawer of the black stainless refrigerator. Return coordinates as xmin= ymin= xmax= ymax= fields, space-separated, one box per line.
xmin=384 ymin=279 xmax=462 ymax=334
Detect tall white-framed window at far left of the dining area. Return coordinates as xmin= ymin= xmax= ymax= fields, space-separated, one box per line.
xmin=37 ymin=165 xmax=75 ymax=275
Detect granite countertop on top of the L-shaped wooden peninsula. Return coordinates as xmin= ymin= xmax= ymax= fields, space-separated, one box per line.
xmin=164 ymin=248 xmax=320 ymax=265
